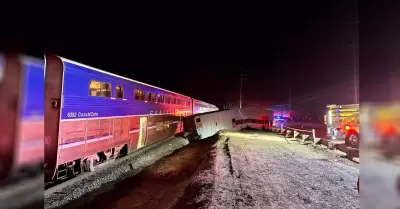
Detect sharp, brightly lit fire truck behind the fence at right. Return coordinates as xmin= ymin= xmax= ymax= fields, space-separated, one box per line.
xmin=325 ymin=104 xmax=360 ymax=149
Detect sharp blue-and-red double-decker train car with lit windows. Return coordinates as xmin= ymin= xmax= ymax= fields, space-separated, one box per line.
xmin=45 ymin=55 xmax=215 ymax=182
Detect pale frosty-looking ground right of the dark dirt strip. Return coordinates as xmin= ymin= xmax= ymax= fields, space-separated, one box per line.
xmin=189 ymin=132 xmax=359 ymax=209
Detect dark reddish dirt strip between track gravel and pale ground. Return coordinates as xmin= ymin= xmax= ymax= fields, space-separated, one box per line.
xmin=57 ymin=137 xmax=217 ymax=209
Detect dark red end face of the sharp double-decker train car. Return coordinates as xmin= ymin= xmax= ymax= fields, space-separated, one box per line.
xmin=44 ymin=55 xmax=64 ymax=182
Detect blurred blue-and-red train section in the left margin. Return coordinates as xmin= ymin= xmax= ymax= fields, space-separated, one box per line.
xmin=0 ymin=55 xmax=44 ymax=181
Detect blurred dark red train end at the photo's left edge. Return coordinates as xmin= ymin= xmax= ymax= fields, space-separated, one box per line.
xmin=0 ymin=55 xmax=22 ymax=180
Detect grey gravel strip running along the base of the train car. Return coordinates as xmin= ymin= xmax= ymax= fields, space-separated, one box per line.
xmin=45 ymin=137 xmax=189 ymax=208
